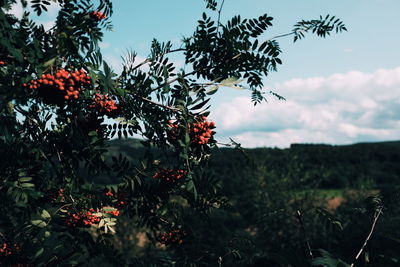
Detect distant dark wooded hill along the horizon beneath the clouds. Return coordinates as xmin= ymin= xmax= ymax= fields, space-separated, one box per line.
xmin=109 ymin=139 xmax=400 ymax=188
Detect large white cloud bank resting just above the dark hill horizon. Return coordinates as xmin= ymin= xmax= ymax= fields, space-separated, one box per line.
xmin=212 ymin=67 xmax=400 ymax=147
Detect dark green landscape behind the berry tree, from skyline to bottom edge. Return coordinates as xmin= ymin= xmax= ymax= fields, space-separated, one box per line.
xmin=106 ymin=140 xmax=400 ymax=266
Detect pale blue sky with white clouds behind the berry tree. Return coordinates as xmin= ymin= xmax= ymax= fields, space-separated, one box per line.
xmin=7 ymin=0 xmax=400 ymax=148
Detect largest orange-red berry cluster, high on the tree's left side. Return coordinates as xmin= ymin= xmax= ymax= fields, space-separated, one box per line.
xmin=22 ymin=69 xmax=91 ymax=100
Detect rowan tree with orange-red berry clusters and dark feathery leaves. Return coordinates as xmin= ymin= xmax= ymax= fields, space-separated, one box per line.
xmin=0 ymin=0 xmax=346 ymax=266
